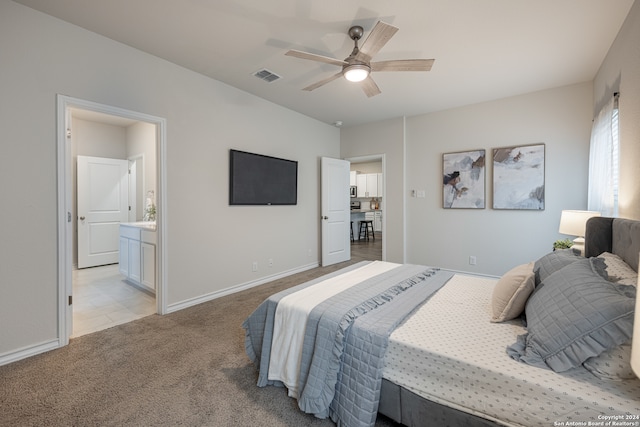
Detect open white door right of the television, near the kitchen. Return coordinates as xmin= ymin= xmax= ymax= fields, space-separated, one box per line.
xmin=321 ymin=157 xmax=351 ymax=266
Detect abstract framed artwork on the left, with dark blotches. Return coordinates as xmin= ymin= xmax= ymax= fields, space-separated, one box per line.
xmin=442 ymin=150 xmax=486 ymax=209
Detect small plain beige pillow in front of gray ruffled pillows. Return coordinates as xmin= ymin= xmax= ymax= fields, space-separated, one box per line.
xmin=491 ymin=262 xmax=535 ymax=323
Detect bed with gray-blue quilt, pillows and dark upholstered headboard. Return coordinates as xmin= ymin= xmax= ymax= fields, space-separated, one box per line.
xmin=243 ymin=218 xmax=640 ymax=426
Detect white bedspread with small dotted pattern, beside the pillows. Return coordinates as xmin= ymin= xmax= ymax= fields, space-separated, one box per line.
xmin=383 ymin=274 xmax=640 ymax=426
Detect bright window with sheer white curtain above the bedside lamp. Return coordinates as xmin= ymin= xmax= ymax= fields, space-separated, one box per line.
xmin=588 ymin=94 xmax=620 ymax=217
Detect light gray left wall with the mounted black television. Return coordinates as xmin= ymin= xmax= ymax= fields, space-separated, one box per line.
xmin=0 ymin=0 xmax=340 ymax=360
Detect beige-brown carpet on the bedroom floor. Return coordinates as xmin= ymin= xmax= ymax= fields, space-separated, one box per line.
xmin=0 ymin=264 xmax=395 ymax=427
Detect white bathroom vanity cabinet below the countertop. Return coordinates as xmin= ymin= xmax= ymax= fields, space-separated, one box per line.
xmin=119 ymin=223 xmax=156 ymax=292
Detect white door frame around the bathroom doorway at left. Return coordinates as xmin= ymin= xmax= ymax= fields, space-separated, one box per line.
xmin=56 ymin=94 xmax=168 ymax=347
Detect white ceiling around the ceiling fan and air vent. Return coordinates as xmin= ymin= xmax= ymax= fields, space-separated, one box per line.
xmin=15 ymin=0 xmax=634 ymax=127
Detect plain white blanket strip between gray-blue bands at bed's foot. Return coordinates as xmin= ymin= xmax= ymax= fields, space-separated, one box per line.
xmin=268 ymin=261 xmax=400 ymax=399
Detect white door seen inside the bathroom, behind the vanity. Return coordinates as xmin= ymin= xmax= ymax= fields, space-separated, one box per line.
xmin=77 ymin=156 xmax=129 ymax=268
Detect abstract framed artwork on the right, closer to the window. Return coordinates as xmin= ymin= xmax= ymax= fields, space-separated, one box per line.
xmin=493 ymin=144 xmax=545 ymax=210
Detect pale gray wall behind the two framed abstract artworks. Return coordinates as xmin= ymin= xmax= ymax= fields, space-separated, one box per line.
xmin=341 ymin=83 xmax=592 ymax=275
